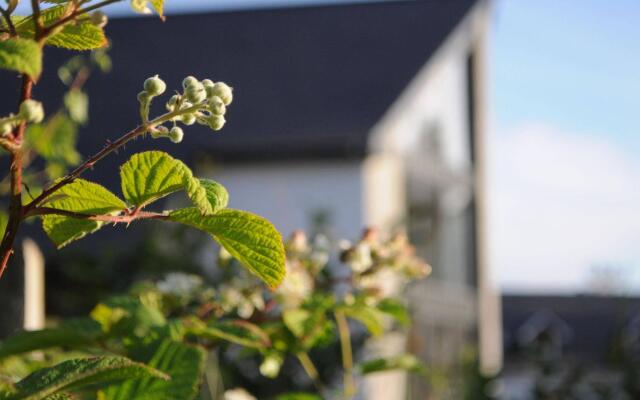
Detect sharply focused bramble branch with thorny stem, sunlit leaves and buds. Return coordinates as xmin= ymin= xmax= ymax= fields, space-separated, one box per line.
xmin=0 ymin=0 xmax=284 ymax=287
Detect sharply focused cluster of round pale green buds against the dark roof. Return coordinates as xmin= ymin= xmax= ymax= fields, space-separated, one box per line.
xmin=138 ymin=75 xmax=233 ymax=143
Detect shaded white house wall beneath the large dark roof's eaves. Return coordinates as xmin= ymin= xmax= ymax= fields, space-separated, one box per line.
xmin=201 ymin=161 xmax=365 ymax=239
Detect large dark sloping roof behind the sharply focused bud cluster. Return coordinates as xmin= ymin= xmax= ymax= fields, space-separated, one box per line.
xmin=0 ymin=0 xmax=476 ymax=169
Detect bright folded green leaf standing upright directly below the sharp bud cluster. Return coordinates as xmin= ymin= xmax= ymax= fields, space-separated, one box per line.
xmin=120 ymin=151 xmax=214 ymax=215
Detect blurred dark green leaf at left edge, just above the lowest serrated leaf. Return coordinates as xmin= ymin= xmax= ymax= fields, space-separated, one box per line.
xmin=0 ymin=318 xmax=102 ymax=359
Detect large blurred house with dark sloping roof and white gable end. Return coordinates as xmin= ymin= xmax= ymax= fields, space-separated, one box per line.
xmin=0 ymin=0 xmax=501 ymax=396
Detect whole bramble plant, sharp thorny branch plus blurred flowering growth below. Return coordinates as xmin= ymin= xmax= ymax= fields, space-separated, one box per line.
xmin=0 ymin=0 xmax=428 ymax=400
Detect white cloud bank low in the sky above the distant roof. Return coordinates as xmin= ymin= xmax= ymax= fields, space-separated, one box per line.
xmin=488 ymin=124 xmax=640 ymax=290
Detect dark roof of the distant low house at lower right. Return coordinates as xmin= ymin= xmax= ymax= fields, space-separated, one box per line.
xmin=502 ymin=295 xmax=640 ymax=360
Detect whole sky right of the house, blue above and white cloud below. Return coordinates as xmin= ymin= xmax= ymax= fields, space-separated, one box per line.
xmin=488 ymin=0 xmax=640 ymax=293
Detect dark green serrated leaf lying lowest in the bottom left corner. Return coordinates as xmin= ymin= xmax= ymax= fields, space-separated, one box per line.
xmin=10 ymin=357 xmax=169 ymax=400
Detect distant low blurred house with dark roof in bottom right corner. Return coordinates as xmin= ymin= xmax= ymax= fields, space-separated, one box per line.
xmin=502 ymin=295 xmax=640 ymax=400
